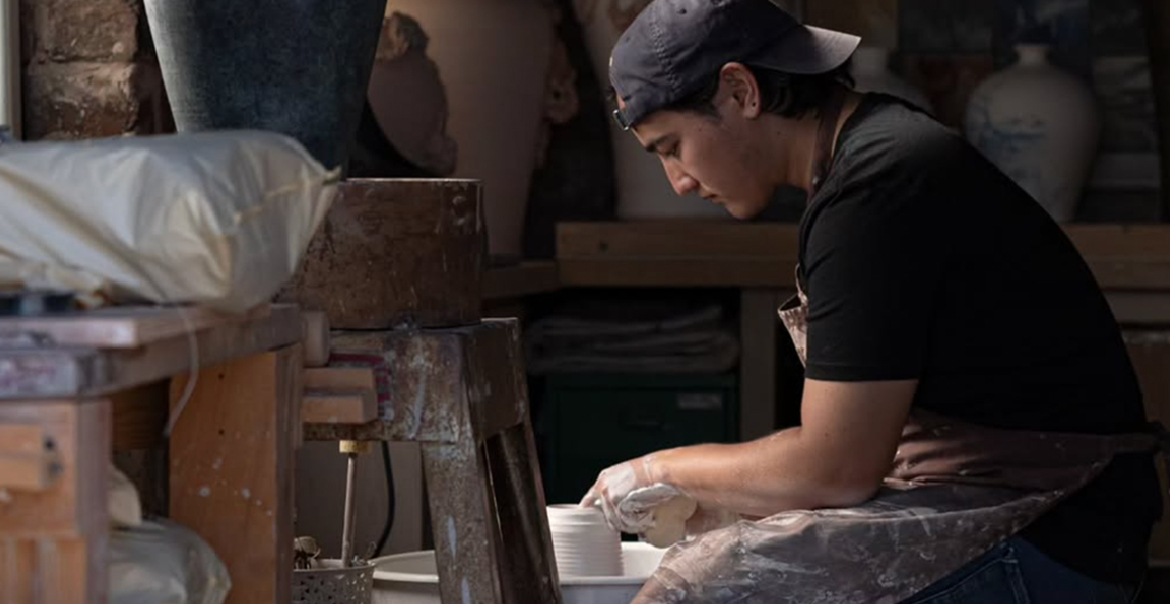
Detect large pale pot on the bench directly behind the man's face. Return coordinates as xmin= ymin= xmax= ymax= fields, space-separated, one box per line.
xmin=573 ymin=0 xmax=730 ymax=220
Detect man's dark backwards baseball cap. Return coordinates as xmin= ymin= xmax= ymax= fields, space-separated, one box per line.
xmin=610 ymin=0 xmax=861 ymax=130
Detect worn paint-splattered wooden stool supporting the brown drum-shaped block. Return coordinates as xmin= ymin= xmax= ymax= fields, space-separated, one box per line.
xmin=305 ymin=320 xmax=562 ymax=604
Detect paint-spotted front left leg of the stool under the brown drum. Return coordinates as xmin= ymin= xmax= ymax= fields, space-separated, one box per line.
xmin=422 ymin=440 xmax=504 ymax=604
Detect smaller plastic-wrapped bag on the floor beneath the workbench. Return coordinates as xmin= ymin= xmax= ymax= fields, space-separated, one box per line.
xmin=109 ymin=519 xmax=232 ymax=604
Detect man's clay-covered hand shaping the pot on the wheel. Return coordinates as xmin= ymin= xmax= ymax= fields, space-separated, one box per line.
xmin=580 ymin=454 xmax=683 ymax=534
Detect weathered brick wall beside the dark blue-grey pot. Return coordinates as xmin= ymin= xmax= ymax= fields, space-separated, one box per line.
xmin=20 ymin=0 xmax=173 ymax=140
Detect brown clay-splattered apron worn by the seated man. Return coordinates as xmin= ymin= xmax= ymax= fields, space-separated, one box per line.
xmin=633 ymin=90 xmax=1168 ymax=604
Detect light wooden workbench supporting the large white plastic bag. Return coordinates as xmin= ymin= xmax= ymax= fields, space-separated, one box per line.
xmin=0 ymin=306 xmax=302 ymax=604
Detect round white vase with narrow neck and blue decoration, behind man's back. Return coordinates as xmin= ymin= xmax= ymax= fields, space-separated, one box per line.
xmin=966 ymin=44 xmax=1101 ymax=222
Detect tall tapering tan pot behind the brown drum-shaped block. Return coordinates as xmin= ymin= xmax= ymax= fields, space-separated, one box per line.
xmin=379 ymin=0 xmax=553 ymax=256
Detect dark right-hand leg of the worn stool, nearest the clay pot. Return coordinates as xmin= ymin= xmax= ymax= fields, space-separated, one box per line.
xmin=487 ymin=420 xmax=560 ymax=604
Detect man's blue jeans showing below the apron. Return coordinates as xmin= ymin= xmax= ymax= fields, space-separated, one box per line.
xmin=906 ymin=537 xmax=1137 ymax=604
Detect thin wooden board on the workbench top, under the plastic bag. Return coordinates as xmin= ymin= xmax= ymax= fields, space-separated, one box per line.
xmin=0 ymin=304 xmax=269 ymax=348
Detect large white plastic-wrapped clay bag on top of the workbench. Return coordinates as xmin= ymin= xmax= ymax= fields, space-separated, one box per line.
xmin=0 ymin=131 xmax=340 ymax=313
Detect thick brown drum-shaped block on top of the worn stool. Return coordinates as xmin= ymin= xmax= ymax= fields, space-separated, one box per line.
xmin=278 ymin=179 xmax=484 ymax=329
